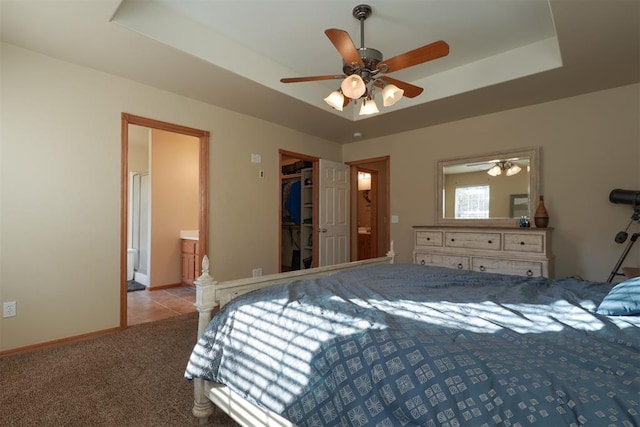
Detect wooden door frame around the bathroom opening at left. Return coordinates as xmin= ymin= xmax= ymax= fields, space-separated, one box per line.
xmin=120 ymin=113 xmax=209 ymax=329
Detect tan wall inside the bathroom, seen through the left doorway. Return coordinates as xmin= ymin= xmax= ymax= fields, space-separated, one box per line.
xmin=149 ymin=129 xmax=200 ymax=288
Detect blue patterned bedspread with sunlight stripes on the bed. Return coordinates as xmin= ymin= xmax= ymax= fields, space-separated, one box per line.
xmin=185 ymin=265 xmax=640 ymax=426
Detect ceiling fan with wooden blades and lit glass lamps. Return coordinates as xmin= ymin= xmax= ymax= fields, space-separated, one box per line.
xmin=280 ymin=4 xmax=449 ymax=115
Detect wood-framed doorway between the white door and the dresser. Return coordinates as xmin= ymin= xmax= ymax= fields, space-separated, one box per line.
xmin=348 ymin=156 xmax=391 ymax=261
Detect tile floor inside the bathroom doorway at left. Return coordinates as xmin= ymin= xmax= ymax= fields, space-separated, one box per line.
xmin=127 ymin=286 xmax=196 ymax=326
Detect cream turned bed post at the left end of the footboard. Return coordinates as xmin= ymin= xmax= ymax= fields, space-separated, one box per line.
xmin=191 ymin=255 xmax=218 ymax=424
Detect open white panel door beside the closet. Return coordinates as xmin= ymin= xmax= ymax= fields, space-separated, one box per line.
xmin=317 ymin=159 xmax=350 ymax=266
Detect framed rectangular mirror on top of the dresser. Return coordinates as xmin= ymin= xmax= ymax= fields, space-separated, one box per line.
xmin=436 ymin=147 xmax=540 ymax=227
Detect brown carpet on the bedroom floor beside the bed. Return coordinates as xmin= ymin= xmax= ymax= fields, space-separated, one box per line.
xmin=0 ymin=313 xmax=238 ymax=427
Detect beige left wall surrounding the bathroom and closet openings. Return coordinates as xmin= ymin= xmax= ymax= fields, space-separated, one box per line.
xmin=0 ymin=44 xmax=341 ymax=351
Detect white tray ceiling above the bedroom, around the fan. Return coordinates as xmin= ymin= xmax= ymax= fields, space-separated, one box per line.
xmin=0 ymin=0 xmax=640 ymax=143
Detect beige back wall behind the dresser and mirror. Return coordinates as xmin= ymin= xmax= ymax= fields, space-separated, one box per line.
xmin=343 ymin=84 xmax=640 ymax=281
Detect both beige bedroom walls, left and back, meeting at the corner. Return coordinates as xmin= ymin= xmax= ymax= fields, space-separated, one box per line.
xmin=0 ymin=44 xmax=640 ymax=351
